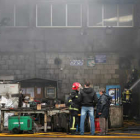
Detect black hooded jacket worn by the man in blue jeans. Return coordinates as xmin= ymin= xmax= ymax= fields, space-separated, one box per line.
xmin=80 ymin=88 xmax=98 ymax=107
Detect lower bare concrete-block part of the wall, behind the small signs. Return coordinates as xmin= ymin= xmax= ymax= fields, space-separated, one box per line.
xmin=0 ymin=52 xmax=137 ymax=99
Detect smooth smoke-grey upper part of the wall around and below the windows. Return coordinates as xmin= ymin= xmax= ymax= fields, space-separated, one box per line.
xmin=0 ymin=0 xmax=140 ymax=53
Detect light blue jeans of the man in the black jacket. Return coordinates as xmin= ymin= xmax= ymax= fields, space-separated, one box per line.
xmin=80 ymin=106 xmax=95 ymax=135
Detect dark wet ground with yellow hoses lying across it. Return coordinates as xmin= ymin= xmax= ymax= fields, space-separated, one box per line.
xmin=0 ymin=120 xmax=140 ymax=140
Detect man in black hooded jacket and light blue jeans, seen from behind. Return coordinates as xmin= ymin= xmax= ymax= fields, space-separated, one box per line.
xmin=80 ymin=81 xmax=98 ymax=135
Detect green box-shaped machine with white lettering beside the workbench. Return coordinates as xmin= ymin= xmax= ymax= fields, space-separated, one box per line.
xmin=8 ymin=116 xmax=34 ymax=134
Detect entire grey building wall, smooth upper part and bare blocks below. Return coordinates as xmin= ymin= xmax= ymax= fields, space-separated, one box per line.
xmin=0 ymin=0 xmax=140 ymax=99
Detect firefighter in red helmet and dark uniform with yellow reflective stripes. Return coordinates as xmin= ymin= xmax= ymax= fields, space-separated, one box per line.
xmin=68 ymin=82 xmax=81 ymax=134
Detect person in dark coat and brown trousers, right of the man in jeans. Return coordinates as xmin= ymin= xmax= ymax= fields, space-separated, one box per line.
xmin=97 ymin=88 xmax=111 ymax=135
